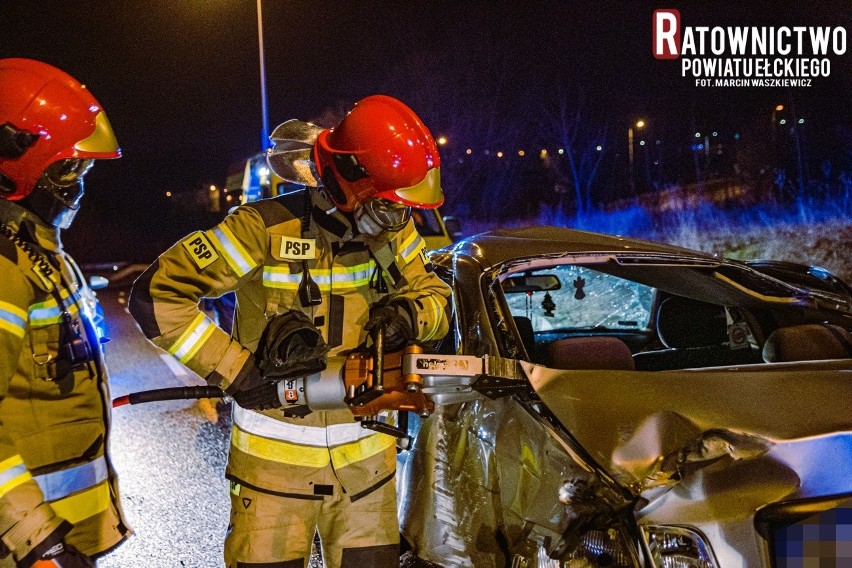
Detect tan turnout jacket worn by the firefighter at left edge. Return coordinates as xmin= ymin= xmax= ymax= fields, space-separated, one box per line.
xmin=0 ymin=199 xmax=129 ymax=566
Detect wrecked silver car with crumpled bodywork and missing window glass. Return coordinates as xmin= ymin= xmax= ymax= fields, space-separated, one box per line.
xmin=399 ymin=227 xmax=852 ymax=568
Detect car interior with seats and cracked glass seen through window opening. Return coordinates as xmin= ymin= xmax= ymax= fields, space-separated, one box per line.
xmin=502 ymin=265 xmax=852 ymax=371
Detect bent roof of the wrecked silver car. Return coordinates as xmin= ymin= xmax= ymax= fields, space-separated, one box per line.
xmin=431 ymin=226 xmax=852 ymax=318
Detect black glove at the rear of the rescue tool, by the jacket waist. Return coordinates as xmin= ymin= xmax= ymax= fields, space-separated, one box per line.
xmin=257 ymin=310 xmax=328 ymax=381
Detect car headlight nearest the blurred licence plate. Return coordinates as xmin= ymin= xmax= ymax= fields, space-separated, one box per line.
xmin=641 ymin=525 xmax=719 ymax=568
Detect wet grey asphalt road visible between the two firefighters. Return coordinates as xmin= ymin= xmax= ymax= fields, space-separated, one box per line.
xmin=98 ymin=289 xmax=230 ymax=568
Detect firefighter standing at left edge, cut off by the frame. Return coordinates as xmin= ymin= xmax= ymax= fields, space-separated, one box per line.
xmin=0 ymin=59 xmax=129 ymax=568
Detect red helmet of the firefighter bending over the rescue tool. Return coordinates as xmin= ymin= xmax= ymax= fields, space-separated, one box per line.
xmin=313 ymin=95 xmax=444 ymax=211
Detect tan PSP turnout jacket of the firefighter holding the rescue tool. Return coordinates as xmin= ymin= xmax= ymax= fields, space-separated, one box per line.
xmin=130 ymin=192 xmax=450 ymax=497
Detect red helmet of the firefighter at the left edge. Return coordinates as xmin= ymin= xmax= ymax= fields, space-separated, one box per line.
xmin=0 ymin=59 xmax=121 ymax=200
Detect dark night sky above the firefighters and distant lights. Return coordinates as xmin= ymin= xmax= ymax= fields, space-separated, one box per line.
xmin=0 ymin=0 xmax=852 ymax=261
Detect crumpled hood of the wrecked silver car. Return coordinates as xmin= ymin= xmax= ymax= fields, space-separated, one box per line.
xmin=522 ymin=360 xmax=852 ymax=500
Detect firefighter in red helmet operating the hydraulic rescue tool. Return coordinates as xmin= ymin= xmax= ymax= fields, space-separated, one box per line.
xmin=129 ymin=95 xmax=450 ymax=568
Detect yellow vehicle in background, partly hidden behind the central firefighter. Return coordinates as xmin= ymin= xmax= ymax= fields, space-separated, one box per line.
xmin=221 ymin=153 xmax=461 ymax=250
